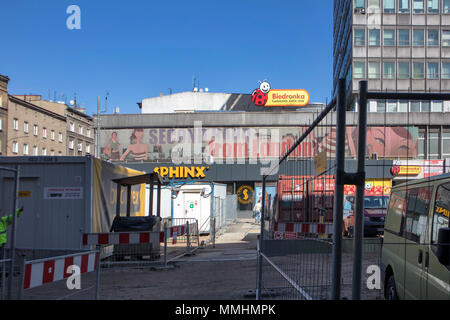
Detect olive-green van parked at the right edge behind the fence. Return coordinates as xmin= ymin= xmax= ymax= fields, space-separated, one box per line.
xmin=381 ymin=174 xmax=450 ymax=300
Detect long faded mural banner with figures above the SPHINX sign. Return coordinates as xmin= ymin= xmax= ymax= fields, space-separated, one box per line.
xmin=100 ymin=127 xmax=419 ymax=163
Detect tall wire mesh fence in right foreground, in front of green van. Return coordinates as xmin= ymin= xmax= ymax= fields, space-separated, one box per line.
xmin=258 ymin=79 xmax=450 ymax=300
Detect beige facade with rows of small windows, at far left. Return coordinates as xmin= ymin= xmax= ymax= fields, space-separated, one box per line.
xmin=6 ymin=96 xmax=66 ymax=156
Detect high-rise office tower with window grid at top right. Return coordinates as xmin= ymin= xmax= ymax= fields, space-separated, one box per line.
xmin=333 ymin=0 xmax=450 ymax=113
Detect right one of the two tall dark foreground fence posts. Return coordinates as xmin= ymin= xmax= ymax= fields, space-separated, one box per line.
xmin=352 ymin=81 xmax=367 ymax=300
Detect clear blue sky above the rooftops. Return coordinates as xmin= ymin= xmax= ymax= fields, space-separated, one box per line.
xmin=0 ymin=0 xmax=333 ymax=114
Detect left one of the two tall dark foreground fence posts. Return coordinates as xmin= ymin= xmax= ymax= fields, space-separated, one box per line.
xmin=331 ymin=79 xmax=346 ymax=300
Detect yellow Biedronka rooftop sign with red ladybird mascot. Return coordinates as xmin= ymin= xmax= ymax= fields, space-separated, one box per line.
xmin=252 ymin=81 xmax=309 ymax=107
